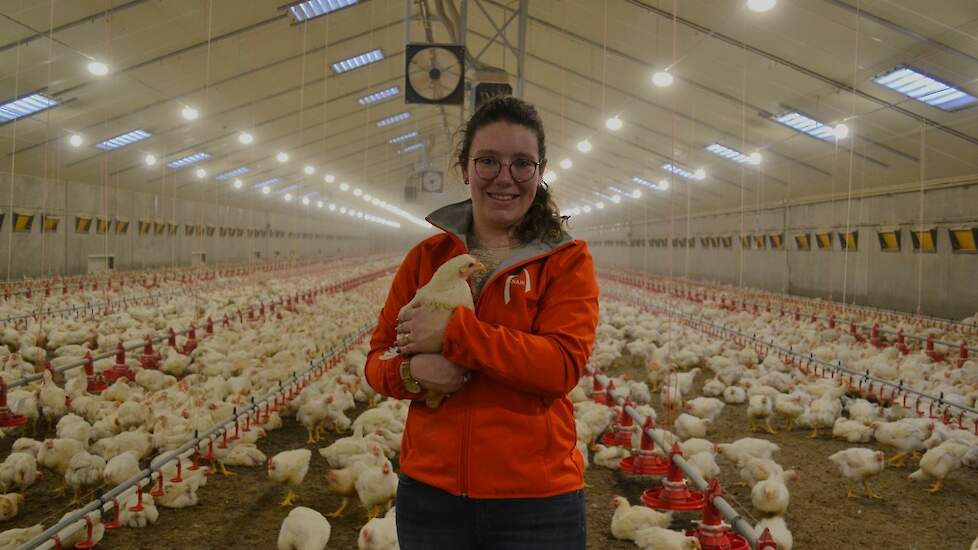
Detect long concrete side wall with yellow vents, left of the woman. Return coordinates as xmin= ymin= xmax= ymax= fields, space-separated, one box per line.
xmin=0 ymin=174 xmax=417 ymax=279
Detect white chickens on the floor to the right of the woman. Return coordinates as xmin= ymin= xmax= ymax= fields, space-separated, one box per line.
xmin=570 ymin=282 xmax=978 ymax=550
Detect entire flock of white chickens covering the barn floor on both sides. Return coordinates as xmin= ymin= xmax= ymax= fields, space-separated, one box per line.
xmin=0 ymin=259 xmax=978 ymax=550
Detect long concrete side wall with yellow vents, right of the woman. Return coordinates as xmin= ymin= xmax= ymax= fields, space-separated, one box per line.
xmin=574 ymin=185 xmax=978 ymax=318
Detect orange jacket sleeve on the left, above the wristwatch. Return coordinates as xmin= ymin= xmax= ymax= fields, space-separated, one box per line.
xmin=364 ymin=246 xmax=424 ymax=399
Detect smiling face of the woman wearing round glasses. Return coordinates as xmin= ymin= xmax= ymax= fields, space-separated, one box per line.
xmin=462 ymin=121 xmax=546 ymax=236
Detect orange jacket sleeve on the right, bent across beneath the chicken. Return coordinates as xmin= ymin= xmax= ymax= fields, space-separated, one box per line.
xmin=442 ymin=243 xmax=598 ymax=399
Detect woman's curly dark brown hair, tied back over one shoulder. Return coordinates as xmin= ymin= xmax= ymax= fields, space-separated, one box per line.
xmin=455 ymin=96 xmax=567 ymax=244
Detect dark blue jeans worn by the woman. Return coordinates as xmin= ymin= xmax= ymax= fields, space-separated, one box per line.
xmin=395 ymin=474 xmax=587 ymax=550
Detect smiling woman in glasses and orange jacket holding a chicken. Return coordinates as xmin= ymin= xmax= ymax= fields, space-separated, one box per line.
xmin=366 ymin=97 xmax=598 ymax=550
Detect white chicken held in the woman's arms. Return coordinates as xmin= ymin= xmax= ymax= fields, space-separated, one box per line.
xmin=381 ymin=254 xmax=486 ymax=409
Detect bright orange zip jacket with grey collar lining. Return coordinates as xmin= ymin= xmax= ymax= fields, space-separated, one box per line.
xmin=366 ymin=201 xmax=598 ymax=498
